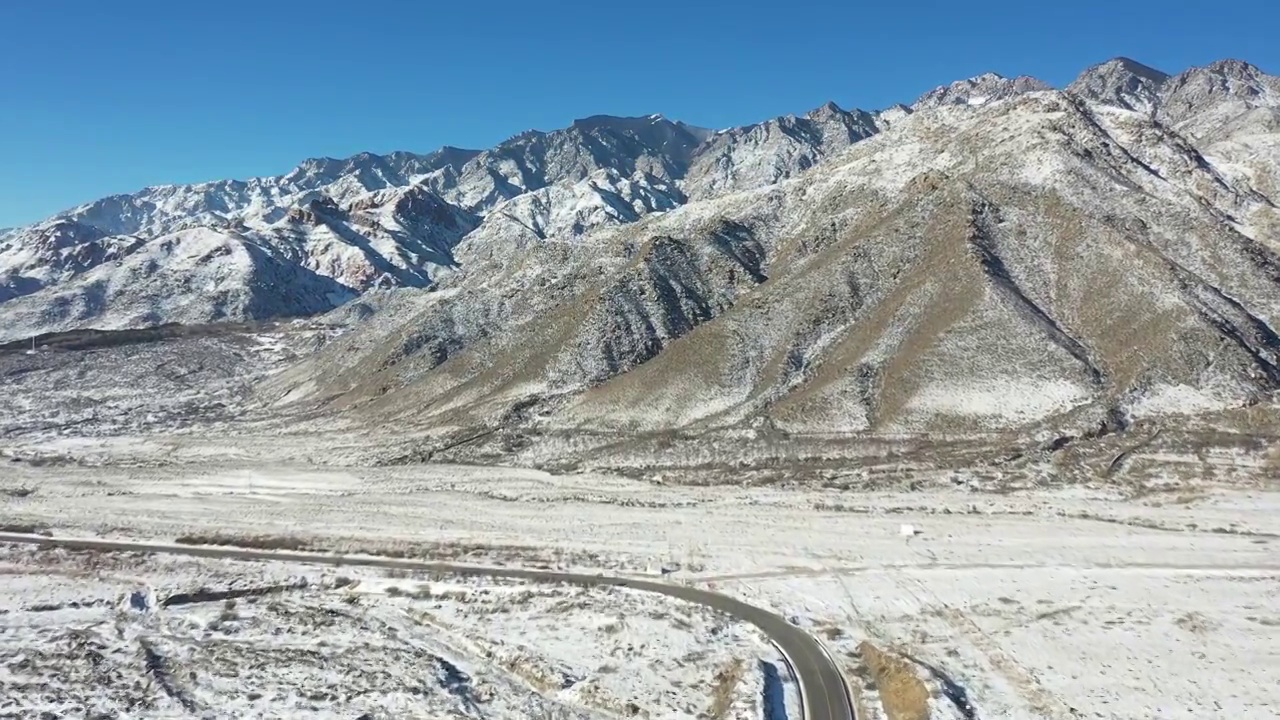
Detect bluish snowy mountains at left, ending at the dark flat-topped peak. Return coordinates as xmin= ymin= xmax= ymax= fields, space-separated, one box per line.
xmin=0 ymin=115 xmax=732 ymax=338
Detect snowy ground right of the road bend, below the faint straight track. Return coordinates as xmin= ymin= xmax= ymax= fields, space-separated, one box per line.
xmin=718 ymin=561 xmax=1280 ymax=720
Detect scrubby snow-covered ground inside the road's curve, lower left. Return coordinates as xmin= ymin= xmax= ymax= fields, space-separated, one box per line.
xmin=0 ymin=548 xmax=796 ymax=719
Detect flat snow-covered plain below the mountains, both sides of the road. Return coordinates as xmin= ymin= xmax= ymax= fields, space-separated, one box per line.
xmin=0 ymin=462 xmax=1280 ymax=720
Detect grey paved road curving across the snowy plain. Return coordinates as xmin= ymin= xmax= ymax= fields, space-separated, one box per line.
xmin=0 ymin=533 xmax=855 ymax=720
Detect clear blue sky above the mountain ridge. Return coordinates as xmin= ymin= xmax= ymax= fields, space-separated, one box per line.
xmin=0 ymin=0 xmax=1280 ymax=227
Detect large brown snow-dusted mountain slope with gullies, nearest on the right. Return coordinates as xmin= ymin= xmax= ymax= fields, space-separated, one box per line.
xmin=264 ymin=85 xmax=1280 ymax=433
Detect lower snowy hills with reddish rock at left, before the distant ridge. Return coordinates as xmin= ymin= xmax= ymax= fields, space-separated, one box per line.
xmin=0 ymin=180 xmax=479 ymax=340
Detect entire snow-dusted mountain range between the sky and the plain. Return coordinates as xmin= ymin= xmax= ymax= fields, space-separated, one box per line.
xmin=0 ymin=59 xmax=1280 ymax=434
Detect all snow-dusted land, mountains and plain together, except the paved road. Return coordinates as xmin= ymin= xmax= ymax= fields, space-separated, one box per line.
xmin=0 ymin=63 xmax=1280 ymax=720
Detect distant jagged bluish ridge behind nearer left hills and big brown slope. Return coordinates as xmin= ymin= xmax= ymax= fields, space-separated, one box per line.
xmin=0 ymin=65 xmax=1111 ymax=337
